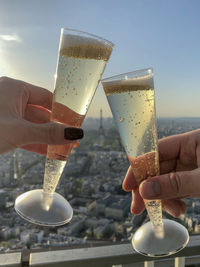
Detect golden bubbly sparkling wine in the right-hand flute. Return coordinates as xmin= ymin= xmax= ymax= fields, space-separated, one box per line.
xmin=102 ymin=75 xmax=162 ymax=235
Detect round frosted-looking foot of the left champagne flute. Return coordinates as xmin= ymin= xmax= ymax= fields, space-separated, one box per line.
xmin=15 ymin=189 xmax=73 ymax=226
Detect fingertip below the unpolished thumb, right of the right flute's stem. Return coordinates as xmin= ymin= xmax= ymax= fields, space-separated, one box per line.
xmin=162 ymin=199 xmax=186 ymax=217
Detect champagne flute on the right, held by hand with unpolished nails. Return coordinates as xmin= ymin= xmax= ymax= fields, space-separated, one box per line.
xmin=102 ymin=68 xmax=189 ymax=257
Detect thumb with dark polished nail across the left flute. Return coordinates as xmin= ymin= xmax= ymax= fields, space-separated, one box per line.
xmin=15 ymin=120 xmax=83 ymax=146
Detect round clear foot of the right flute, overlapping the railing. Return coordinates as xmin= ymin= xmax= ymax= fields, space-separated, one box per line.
xmin=132 ymin=219 xmax=189 ymax=257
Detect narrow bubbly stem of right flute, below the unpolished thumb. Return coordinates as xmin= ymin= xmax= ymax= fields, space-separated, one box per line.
xmin=145 ymin=200 xmax=164 ymax=238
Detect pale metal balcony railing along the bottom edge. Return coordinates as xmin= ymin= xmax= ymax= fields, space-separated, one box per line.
xmin=0 ymin=235 xmax=200 ymax=267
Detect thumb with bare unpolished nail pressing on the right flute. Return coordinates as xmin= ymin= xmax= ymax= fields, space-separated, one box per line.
xmin=139 ymin=169 xmax=200 ymax=199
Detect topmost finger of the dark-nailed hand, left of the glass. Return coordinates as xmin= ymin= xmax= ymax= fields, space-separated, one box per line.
xmin=22 ymin=82 xmax=53 ymax=110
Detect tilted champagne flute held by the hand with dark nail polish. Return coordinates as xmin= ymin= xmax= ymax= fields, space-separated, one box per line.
xmin=15 ymin=28 xmax=113 ymax=226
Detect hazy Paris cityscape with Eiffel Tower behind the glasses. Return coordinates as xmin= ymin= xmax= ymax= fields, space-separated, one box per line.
xmin=0 ymin=115 xmax=200 ymax=252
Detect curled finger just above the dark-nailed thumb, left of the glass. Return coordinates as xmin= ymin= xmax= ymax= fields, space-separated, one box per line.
xmin=24 ymin=104 xmax=51 ymax=123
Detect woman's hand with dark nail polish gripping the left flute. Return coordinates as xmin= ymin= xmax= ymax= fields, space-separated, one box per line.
xmin=0 ymin=77 xmax=83 ymax=155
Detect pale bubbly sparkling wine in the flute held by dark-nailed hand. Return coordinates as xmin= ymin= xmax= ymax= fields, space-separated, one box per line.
xmin=43 ymin=31 xmax=112 ymax=193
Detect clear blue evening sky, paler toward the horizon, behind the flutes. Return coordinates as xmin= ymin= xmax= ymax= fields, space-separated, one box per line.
xmin=0 ymin=0 xmax=200 ymax=117
